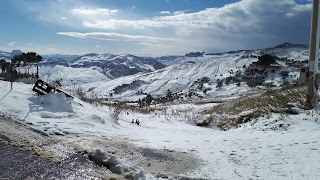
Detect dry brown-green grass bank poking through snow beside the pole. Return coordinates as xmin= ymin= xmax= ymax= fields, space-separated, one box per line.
xmin=202 ymin=84 xmax=306 ymax=130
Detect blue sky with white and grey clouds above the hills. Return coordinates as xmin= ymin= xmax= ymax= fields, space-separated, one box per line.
xmin=0 ymin=0 xmax=312 ymax=56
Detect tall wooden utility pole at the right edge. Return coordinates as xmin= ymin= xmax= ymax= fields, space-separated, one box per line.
xmin=306 ymin=0 xmax=320 ymax=109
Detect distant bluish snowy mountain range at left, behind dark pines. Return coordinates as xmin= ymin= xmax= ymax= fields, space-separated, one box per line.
xmin=0 ymin=50 xmax=165 ymax=79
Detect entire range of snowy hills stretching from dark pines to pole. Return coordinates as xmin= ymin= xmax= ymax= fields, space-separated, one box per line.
xmin=0 ymin=43 xmax=308 ymax=93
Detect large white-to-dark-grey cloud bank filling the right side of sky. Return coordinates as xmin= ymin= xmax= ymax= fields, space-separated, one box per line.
xmin=76 ymin=0 xmax=312 ymax=53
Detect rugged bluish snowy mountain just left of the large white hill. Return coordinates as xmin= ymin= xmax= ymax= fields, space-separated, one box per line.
xmin=69 ymin=53 xmax=165 ymax=79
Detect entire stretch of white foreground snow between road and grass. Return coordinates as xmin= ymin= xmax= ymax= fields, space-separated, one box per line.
xmin=0 ymin=81 xmax=320 ymax=179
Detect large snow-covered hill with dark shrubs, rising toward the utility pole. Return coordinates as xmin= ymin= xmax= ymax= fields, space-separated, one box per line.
xmin=81 ymin=43 xmax=308 ymax=100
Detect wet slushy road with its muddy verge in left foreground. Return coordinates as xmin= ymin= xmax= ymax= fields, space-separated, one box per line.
xmin=0 ymin=115 xmax=197 ymax=179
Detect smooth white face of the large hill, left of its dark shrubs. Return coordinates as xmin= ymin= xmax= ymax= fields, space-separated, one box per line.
xmin=86 ymin=53 xmax=256 ymax=100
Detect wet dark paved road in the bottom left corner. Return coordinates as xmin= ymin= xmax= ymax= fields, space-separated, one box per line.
xmin=0 ymin=116 xmax=117 ymax=180
